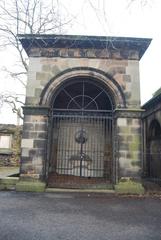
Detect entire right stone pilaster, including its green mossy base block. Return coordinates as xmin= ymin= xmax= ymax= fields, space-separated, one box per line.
xmin=115 ymin=109 xmax=144 ymax=194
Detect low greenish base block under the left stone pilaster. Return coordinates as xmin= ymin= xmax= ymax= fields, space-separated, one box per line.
xmin=16 ymin=180 xmax=46 ymax=192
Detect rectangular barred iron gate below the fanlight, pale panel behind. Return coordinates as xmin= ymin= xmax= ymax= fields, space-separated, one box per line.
xmin=51 ymin=113 xmax=113 ymax=188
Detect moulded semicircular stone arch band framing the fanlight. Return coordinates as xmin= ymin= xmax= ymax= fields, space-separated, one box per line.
xmin=40 ymin=67 xmax=126 ymax=108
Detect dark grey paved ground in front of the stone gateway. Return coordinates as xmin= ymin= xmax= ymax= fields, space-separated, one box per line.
xmin=0 ymin=192 xmax=161 ymax=240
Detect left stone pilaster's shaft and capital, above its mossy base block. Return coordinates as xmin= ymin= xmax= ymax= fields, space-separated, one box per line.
xmin=20 ymin=106 xmax=48 ymax=180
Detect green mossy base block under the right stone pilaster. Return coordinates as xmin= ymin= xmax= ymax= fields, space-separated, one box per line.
xmin=115 ymin=178 xmax=144 ymax=194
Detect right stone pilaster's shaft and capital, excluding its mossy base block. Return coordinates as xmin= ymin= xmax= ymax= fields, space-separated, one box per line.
xmin=116 ymin=110 xmax=142 ymax=178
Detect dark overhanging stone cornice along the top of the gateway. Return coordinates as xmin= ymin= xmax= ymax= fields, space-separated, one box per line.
xmin=18 ymin=34 xmax=151 ymax=59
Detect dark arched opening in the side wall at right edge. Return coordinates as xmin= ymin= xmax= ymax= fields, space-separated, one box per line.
xmin=148 ymin=119 xmax=161 ymax=178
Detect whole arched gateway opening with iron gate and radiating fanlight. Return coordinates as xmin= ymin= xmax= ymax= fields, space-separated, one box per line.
xmin=48 ymin=77 xmax=114 ymax=187
